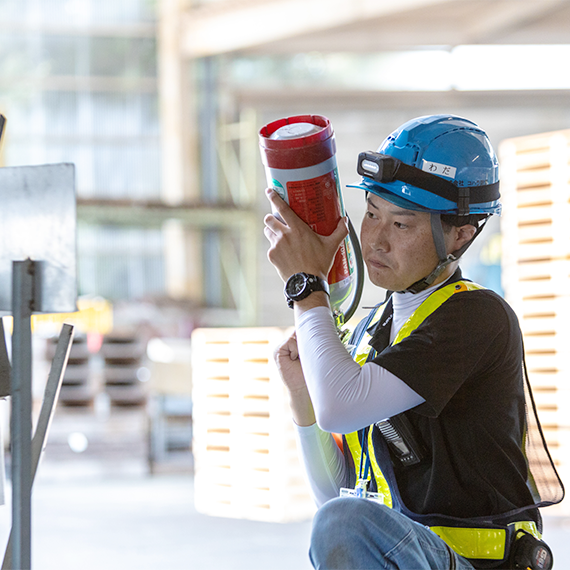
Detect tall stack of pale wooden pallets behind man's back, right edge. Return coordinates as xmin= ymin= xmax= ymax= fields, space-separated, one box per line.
xmin=500 ymin=130 xmax=570 ymax=512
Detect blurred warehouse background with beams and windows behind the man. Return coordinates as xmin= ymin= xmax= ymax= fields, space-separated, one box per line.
xmin=0 ymin=0 xmax=570 ymax=560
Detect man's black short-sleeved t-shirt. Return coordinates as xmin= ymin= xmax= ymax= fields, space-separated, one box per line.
xmin=371 ymin=278 xmax=538 ymax=520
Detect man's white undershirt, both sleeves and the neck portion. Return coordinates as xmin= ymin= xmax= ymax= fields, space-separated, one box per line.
xmin=296 ymin=285 xmax=439 ymax=506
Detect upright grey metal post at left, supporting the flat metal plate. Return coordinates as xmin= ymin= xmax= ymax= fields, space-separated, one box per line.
xmin=11 ymin=259 xmax=35 ymax=570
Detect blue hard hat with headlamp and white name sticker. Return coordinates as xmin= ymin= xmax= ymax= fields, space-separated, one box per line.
xmin=349 ymin=115 xmax=501 ymax=215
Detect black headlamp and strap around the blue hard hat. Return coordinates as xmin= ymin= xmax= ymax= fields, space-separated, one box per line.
xmin=356 ymin=151 xmax=500 ymax=216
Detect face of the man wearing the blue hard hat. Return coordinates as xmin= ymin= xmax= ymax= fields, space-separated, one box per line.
xmin=360 ymin=193 xmax=447 ymax=291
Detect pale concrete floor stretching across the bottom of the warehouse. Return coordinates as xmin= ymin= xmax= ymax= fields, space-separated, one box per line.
xmin=0 ymin=404 xmax=570 ymax=570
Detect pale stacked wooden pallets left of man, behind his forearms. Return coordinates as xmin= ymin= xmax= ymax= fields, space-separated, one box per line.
xmin=192 ymin=328 xmax=314 ymax=522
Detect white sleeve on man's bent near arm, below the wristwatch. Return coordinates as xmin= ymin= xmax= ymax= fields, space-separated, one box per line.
xmin=297 ymin=307 xmax=424 ymax=433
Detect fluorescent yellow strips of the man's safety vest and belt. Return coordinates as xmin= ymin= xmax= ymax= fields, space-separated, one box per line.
xmin=344 ymin=281 xmax=541 ymax=560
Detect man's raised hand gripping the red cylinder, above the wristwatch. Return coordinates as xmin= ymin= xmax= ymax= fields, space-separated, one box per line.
xmin=264 ymin=188 xmax=348 ymax=281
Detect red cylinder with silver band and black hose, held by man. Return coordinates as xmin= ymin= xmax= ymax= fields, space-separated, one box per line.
xmin=259 ymin=115 xmax=364 ymax=327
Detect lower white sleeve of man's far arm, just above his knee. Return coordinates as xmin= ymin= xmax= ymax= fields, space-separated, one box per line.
xmin=295 ymin=424 xmax=346 ymax=507
